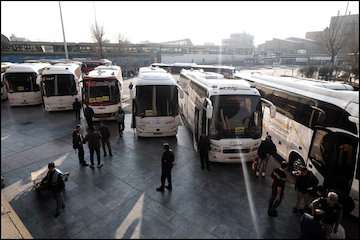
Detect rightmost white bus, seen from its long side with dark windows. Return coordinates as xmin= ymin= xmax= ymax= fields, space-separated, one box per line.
xmin=236 ymin=72 xmax=359 ymax=216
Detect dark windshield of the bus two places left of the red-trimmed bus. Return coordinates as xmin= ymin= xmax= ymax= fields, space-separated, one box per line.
xmin=5 ymin=73 xmax=40 ymax=93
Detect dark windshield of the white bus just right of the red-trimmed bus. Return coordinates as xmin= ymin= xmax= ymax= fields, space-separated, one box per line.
xmin=136 ymin=85 xmax=178 ymax=117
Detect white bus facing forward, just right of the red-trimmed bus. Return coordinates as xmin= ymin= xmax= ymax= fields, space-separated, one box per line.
xmin=131 ymin=67 xmax=180 ymax=137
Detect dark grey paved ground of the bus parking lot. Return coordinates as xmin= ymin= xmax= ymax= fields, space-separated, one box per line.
xmin=1 ymin=83 xmax=358 ymax=238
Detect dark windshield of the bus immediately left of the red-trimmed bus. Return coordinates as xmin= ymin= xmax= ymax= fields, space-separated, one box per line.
xmin=42 ymin=74 xmax=77 ymax=97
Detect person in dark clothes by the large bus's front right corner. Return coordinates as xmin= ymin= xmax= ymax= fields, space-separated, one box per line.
xmin=256 ymin=133 xmax=277 ymax=177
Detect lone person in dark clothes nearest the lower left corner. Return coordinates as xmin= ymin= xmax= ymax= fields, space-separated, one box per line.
xmin=41 ymin=162 xmax=65 ymax=217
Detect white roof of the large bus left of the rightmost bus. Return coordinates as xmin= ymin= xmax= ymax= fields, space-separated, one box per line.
xmin=181 ymin=69 xmax=260 ymax=95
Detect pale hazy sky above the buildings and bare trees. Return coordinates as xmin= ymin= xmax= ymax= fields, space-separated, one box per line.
xmin=1 ymin=1 xmax=359 ymax=45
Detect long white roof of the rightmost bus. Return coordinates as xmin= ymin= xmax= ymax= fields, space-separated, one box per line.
xmin=236 ymin=72 xmax=359 ymax=118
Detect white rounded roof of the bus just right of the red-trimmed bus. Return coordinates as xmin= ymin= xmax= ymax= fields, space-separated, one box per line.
xmin=135 ymin=71 xmax=176 ymax=86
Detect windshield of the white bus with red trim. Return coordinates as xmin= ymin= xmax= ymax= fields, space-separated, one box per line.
xmin=84 ymin=79 xmax=120 ymax=105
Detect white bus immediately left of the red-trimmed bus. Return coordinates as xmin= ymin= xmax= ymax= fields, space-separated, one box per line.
xmin=41 ymin=63 xmax=82 ymax=111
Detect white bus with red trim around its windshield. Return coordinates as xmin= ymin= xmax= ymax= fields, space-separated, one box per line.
xmin=83 ymin=65 xmax=123 ymax=120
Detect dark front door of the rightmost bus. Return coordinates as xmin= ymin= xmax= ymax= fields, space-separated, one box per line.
xmin=307 ymin=128 xmax=359 ymax=196
